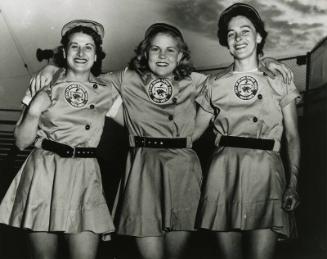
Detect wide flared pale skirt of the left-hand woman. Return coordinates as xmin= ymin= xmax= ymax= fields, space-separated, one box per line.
xmin=0 ymin=149 xmax=114 ymax=240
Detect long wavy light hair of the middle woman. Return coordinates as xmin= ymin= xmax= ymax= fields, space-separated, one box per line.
xmin=128 ymin=25 xmax=194 ymax=81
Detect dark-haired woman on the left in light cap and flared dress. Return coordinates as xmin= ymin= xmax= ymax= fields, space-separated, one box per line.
xmin=0 ymin=20 xmax=119 ymax=259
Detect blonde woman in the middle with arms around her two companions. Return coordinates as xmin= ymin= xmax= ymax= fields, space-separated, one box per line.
xmin=29 ymin=23 xmax=294 ymax=259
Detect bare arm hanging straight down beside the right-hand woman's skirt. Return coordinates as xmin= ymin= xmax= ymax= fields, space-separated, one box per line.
xmin=283 ymin=101 xmax=300 ymax=211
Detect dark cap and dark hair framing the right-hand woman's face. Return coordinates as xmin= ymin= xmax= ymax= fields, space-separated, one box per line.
xmin=217 ymin=3 xmax=267 ymax=46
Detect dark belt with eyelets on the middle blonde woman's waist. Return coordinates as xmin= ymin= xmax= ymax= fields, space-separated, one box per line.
xmin=134 ymin=136 xmax=187 ymax=148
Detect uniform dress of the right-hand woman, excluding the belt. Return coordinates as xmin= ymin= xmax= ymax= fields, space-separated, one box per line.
xmin=196 ymin=68 xmax=299 ymax=237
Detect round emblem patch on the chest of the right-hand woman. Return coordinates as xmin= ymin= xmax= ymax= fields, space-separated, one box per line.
xmin=234 ymin=76 xmax=258 ymax=100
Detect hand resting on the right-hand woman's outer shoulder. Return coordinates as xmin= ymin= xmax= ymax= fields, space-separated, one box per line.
xmin=259 ymin=58 xmax=294 ymax=84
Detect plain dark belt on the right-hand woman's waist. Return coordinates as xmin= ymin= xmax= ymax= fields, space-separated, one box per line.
xmin=219 ymin=136 xmax=275 ymax=150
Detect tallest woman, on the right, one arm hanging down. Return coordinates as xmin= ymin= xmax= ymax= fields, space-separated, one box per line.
xmin=194 ymin=3 xmax=300 ymax=259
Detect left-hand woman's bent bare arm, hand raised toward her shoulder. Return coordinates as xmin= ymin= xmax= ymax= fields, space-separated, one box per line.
xmin=14 ymin=91 xmax=50 ymax=150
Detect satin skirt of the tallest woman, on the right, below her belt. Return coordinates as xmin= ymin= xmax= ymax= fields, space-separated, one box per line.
xmin=196 ymin=147 xmax=290 ymax=241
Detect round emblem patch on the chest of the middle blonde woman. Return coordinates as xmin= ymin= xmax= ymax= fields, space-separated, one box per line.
xmin=148 ymin=78 xmax=173 ymax=104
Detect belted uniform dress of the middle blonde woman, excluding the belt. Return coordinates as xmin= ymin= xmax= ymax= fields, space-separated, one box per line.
xmin=105 ymin=70 xmax=205 ymax=237
